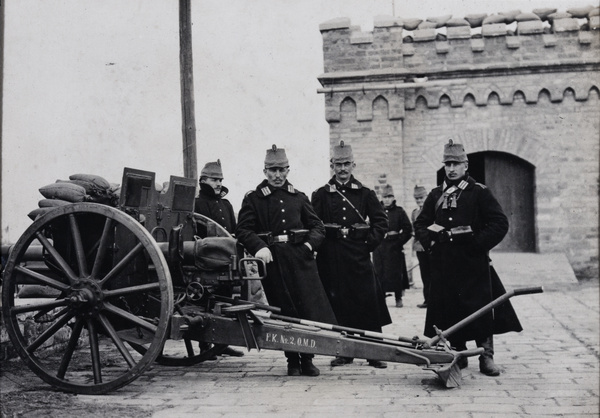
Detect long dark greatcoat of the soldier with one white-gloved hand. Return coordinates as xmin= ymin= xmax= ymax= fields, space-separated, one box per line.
xmin=236 ymin=180 xmax=336 ymax=324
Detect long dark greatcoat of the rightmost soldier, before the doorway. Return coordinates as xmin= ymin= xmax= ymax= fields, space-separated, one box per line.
xmin=414 ymin=176 xmax=522 ymax=341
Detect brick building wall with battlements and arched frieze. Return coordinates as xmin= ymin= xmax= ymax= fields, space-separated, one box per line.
xmin=319 ymin=9 xmax=600 ymax=277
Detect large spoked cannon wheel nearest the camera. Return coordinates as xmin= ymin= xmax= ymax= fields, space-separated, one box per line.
xmin=2 ymin=203 xmax=173 ymax=394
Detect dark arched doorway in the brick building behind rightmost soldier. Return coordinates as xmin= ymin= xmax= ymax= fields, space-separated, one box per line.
xmin=437 ymin=151 xmax=536 ymax=252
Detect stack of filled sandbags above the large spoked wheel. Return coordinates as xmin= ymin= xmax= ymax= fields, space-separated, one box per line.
xmin=27 ymin=174 xmax=119 ymax=220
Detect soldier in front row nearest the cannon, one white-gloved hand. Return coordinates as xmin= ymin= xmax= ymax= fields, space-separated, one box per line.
xmin=236 ymin=145 xmax=336 ymax=376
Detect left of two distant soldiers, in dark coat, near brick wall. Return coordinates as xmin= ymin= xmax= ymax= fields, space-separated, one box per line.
xmin=373 ymin=184 xmax=412 ymax=308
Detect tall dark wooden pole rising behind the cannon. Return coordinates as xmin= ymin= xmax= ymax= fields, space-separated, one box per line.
xmin=179 ymin=0 xmax=198 ymax=179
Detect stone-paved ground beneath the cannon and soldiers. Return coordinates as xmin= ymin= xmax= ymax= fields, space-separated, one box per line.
xmin=0 ymin=253 xmax=600 ymax=418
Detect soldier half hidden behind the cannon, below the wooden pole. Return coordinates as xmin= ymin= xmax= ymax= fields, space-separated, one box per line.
xmin=194 ymin=160 xmax=244 ymax=359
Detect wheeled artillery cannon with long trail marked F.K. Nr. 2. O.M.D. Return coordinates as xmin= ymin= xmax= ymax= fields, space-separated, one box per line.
xmin=2 ymin=168 xmax=542 ymax=394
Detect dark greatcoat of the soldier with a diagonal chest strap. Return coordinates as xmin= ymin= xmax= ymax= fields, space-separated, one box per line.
xmin=312 ymin=176 xmax=392 ymax=332
